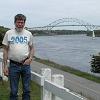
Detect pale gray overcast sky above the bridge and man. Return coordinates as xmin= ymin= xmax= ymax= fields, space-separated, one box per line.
xmin=0 ymin=0 xmax=100 ymax=28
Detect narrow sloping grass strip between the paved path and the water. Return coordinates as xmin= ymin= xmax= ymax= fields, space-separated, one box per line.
xmin=34 ymin=57 xmax=100 ymax=83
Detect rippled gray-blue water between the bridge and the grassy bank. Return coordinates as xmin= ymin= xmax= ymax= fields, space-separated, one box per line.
xmin=34 ymin=35 xmax=100 ymax=72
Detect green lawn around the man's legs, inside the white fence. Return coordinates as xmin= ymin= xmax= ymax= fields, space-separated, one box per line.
xmin=0 ymin=81 xmax=41 ymax=100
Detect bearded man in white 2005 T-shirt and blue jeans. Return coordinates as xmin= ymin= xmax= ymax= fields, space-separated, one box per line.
xmin=2 ymin=14 xmax=34 ymax=100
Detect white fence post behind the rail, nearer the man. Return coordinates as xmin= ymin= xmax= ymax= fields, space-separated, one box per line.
xmin=41 ymin=68 xmax=51 ymax=100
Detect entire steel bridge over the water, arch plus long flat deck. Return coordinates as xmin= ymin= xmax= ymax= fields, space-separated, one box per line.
xmin=28 ymin=18 xmax=100 ymax=31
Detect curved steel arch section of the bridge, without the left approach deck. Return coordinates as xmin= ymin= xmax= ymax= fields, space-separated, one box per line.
xmin=44 ymin=18 xmax=96 ymax=31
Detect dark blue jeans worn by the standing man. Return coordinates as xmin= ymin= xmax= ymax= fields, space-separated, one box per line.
xmin=9 ymin=63 xmax=31 ymax=100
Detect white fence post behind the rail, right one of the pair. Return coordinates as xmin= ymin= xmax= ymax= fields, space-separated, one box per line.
xmin=52 ymin=74 xmax=64 ymax=100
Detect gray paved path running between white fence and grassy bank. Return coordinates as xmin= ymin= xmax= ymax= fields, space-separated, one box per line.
xmin=31 ymin=61 xmax=100 ymax=100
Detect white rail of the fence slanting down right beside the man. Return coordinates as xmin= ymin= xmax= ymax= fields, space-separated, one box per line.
xmin=31 ymin=72 xmax=86 ymax=100
